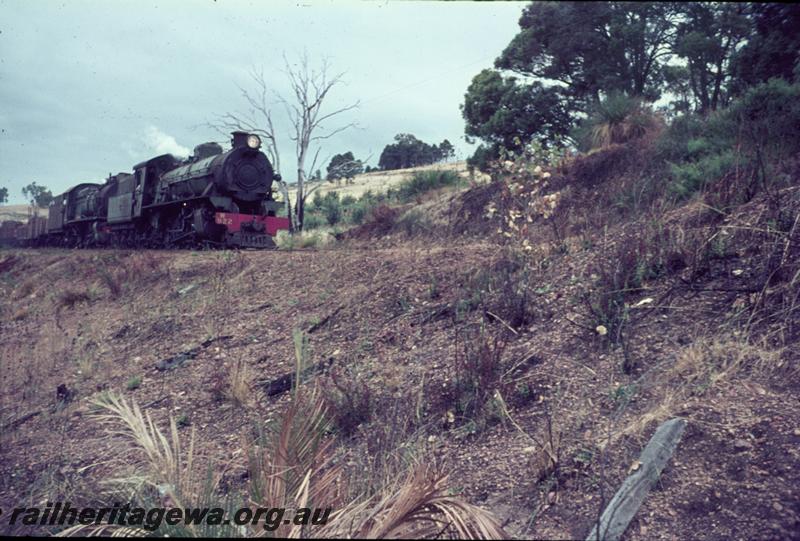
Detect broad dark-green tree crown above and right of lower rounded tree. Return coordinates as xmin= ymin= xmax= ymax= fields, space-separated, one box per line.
xmin=495 ymin=2 xmax=678 ymax=106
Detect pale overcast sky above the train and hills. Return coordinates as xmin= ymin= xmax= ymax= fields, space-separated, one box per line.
xmin=0 ymin=0 xmax=526 ymax=204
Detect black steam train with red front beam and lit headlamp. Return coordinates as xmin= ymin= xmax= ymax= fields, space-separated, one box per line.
xmin=0 ymin=131 xmax=289 ymax=248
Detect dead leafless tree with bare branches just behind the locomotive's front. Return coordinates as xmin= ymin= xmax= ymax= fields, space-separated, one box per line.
xmin=209 ymin=53 xmax=359 ymax=231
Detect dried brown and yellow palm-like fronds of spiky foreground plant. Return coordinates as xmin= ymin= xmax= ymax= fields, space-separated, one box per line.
xmin=59 ymin=388 xmax=508 ymax=539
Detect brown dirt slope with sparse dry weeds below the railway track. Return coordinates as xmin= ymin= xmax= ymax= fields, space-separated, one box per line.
xmin=0 ymin=171 xmax=800 ymax=539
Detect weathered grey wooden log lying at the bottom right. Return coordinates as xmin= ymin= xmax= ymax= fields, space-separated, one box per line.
xmin=586 ymin=418 xmax=686 ymax=541
